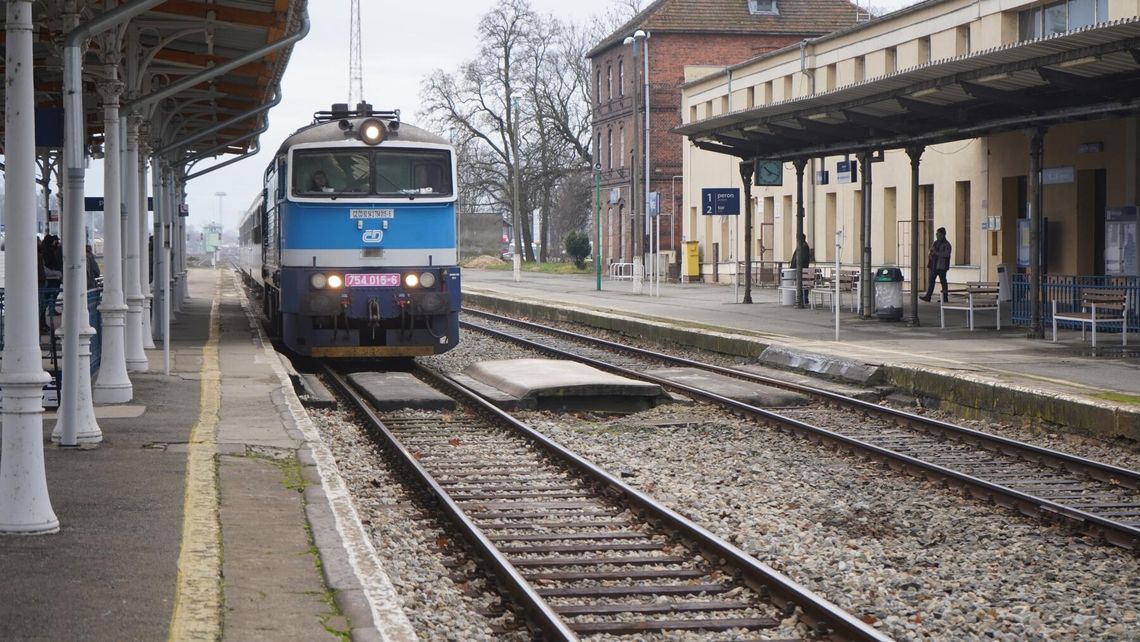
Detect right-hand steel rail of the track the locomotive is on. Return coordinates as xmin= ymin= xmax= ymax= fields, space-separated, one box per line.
xmin=416 ymin=363 xmax=890 ymax=641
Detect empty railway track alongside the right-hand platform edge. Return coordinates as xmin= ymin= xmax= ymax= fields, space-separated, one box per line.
xmin=463 ymin=308 xmax=1140 ymax=550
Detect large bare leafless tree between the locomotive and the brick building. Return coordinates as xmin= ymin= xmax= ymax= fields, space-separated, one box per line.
xmin=422 ymin=0 xmax=642 ymax=261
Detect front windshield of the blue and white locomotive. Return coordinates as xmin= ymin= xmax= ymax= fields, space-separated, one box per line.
xmin=293 ymin=148 xmax=453 ymax=197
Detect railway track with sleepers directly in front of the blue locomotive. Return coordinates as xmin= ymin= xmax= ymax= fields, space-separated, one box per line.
xmin=324 ymin=366 xmax=887 ymax=640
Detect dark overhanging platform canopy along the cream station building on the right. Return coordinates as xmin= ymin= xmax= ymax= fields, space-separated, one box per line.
xmin=674 ymin=16 xmax=1140 ymax=161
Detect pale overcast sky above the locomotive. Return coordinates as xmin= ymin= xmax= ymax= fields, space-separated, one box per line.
xmin=171 ymin=0 xmax=913 ymax=230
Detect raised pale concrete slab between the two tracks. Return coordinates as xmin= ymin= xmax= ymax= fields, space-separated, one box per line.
xmin=463 ymin=359 xmax=669 ymax=413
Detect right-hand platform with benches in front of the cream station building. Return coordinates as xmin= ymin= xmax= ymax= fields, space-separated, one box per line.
xmin=461 ymin=268 xmax=1140 ymax=440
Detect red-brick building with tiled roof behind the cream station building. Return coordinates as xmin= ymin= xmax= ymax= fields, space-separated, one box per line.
xmin=587 ymin=0 xmax=865 ymax=274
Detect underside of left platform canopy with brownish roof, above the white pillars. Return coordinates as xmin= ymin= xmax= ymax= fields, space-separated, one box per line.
xmin=0 ymin=0 xmax=308 ymax=165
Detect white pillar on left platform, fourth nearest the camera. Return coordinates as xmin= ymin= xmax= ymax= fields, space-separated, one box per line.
xmin=122 ymin=115 xmax=150 ymax=372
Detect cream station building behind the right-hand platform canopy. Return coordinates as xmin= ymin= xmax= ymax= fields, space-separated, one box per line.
xmin=676 ymin=0 xmax=1140 ymax=320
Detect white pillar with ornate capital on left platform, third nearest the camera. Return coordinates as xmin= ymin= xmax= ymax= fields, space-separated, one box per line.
xmin=92 ymin=72 xmax=135 ymax=404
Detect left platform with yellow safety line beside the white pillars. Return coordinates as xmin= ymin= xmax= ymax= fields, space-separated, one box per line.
xmin=0 ymin=269 xmax=415 ymax=640
